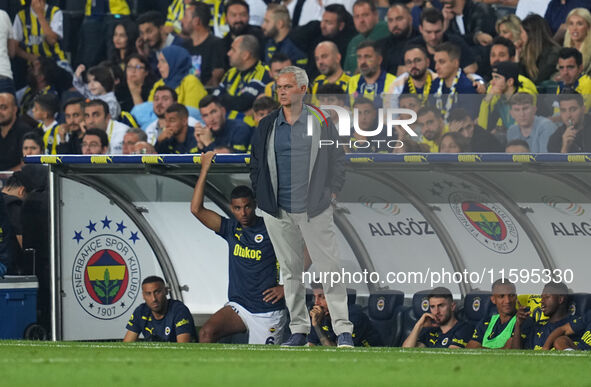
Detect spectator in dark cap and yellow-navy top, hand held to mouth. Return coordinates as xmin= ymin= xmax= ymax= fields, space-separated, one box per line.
xmin=478 ymin=61 xmax=521 ymax=130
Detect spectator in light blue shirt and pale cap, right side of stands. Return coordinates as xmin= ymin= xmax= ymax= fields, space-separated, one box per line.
xmin=507 ymin=93 xmax=556 ymax=153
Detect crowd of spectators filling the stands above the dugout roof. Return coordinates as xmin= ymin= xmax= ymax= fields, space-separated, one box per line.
xmin=0 ymin=0 xmax=591 ymax=170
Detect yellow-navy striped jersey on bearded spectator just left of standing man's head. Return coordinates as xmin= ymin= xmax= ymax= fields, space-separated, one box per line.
xmin=214 ymin=61 xmax=271 ymax=126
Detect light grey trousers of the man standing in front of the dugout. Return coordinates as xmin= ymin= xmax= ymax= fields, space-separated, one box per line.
xmin=263 ymin=206 xmax=353 ymax=335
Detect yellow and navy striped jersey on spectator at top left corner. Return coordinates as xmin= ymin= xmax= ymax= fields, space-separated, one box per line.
xmin=18 ymin=6 xmax=66 ymax=61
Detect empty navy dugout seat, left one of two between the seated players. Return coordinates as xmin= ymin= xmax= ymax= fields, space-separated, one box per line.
xmin=367 ymin=290 xmax=404 ymax=347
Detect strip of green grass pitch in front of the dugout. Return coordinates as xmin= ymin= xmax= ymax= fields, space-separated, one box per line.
xmin=0 ymin=341 xmax=591 ymax=387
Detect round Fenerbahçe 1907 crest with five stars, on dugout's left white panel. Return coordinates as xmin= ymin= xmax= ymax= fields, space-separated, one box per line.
xmin=72 ymin=216 xmax=141 ymax=320
